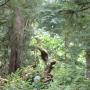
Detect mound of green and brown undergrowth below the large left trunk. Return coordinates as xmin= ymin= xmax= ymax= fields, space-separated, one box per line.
xmin=3 ymin=66 xmax=47 ymax=90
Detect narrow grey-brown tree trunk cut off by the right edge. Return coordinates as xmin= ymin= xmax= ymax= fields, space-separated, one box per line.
xmin=86 ymin=49 xmax=90 ymax=79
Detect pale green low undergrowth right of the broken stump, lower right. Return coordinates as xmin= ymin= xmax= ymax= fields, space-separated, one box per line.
xmin=47 ymin=63 xmax=90 ymax=90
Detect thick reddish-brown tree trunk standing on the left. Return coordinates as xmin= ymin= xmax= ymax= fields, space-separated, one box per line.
xmin=9 ymin=8 xmax=24 ymax=73
